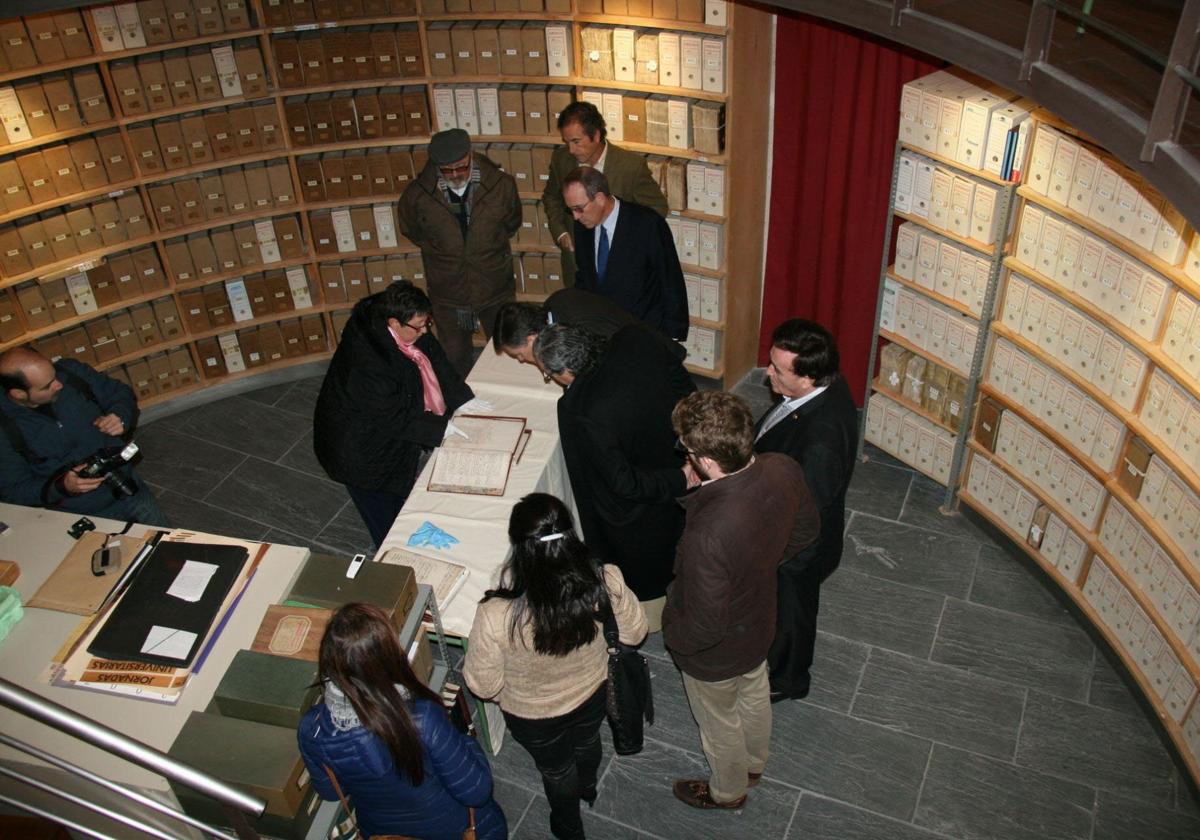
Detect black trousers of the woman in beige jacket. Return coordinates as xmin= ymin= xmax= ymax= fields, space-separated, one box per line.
xmin=504 ymin=684 xmax=606 ymax=840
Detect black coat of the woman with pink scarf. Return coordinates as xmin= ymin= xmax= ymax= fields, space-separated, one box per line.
xmin=312 ymin=293 xmax=473 ymax=494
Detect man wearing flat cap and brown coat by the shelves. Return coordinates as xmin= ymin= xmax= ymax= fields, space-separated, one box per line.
xmin=400 ymin=128 xmax=521 ymax=377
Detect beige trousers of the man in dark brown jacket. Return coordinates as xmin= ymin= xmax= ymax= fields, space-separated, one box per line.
xmin=683 ymin=661 xmax=770 ymax=802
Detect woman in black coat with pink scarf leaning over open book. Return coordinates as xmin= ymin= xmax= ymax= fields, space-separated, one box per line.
xmin=313 ymin=280 xmax=473 ymax=546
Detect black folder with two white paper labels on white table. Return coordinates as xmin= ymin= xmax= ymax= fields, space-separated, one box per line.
xmin=88 ymin=541 xmax=250 ymax=668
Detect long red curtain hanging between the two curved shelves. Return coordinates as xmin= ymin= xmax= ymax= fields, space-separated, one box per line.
xmin=758 ymin=13 xmax=944 ymax=404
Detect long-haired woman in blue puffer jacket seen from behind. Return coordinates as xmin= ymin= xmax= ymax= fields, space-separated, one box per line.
xmin=298 ymin=604 xmax=509 ymax=840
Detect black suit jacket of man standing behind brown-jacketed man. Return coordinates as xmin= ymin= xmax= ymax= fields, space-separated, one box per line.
xmin=754 ymin=373 xmax=858 ymax=576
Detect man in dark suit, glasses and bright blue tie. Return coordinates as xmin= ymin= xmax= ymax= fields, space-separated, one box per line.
xmin=563 ymin=167 xmax=688 ymax=341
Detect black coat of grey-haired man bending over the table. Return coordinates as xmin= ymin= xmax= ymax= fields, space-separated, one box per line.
xmin=558 ymin=324 xmax=696 ymax=601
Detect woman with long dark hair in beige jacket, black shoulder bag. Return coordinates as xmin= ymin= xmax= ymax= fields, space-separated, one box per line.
xmin=463 ymin=493 xmax=646 ymax=840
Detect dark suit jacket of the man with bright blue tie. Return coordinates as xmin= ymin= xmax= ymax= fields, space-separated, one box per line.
xmin=575 ymin=202 xmax=688 ymax=341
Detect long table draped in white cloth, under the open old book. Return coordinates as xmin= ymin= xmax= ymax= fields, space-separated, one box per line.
xmin=376 ymin=346 xmax=575 ymax=636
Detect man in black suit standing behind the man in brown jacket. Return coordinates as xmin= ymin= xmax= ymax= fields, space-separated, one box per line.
xmin=755 ymin=318 xmax=858 ymax=703
